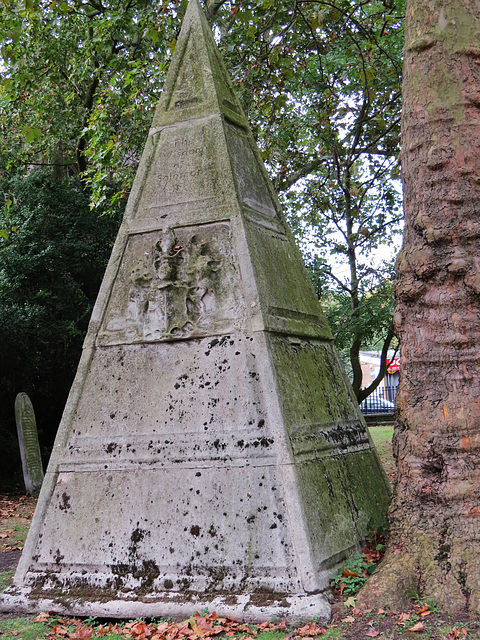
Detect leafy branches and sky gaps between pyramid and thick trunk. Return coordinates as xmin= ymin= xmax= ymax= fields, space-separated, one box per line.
xmin=217 ymin=0 xmax=404 ymax=391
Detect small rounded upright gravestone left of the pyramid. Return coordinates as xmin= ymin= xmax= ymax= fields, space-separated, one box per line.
xmin=15 ymin=393 xmax=43 ymax=496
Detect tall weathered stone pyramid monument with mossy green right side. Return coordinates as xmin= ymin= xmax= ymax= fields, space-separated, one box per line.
xmin=0 ymin=0 xmax=389 ymax=621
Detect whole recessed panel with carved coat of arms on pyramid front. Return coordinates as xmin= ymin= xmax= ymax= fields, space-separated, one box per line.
xmin=98 ymin=223 xmax=244 ymax=345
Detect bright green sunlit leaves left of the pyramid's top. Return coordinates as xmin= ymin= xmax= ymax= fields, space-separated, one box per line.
xmin=0 ymin=0 xmax=182 ymax=205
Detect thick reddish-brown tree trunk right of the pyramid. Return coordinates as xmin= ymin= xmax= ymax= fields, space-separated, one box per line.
xmin=357 ymin=0 xmax=480 ymax=613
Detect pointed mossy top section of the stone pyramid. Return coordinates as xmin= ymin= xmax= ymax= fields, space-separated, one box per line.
xmin=153 ymin=0 xmax=248 ymax=129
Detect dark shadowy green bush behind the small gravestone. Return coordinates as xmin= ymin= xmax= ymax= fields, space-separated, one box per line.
xmin=0 ymin=171 xmax=119 ymax=476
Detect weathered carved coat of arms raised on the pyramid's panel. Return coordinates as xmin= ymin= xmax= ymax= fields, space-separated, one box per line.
xmin=115 ymin=229 xmax=221 ymax=342
